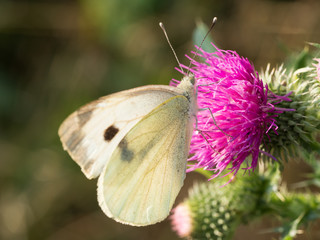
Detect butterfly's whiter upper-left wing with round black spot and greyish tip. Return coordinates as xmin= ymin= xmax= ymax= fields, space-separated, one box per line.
xmin=58 ymin=85 xmax=182 ymax=179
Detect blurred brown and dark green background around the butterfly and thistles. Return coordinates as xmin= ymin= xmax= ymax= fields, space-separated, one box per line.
xmin=0 ymin=0 xmax=320 ymax=240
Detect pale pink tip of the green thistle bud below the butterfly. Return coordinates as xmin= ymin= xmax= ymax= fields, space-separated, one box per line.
xmin=170 ymin=203 xmax=192 ymax=238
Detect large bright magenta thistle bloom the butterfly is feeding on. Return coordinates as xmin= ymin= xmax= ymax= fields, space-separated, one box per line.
xmin=171 ymin=46 xmax=290 ymax=181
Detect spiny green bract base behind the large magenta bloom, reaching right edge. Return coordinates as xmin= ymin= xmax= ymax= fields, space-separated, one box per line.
xmin=261 ymin=61 xmax=320 ymax=161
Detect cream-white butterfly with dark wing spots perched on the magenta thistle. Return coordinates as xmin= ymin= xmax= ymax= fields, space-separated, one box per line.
xmin=59 ymin=75 xmax=197 ymax=226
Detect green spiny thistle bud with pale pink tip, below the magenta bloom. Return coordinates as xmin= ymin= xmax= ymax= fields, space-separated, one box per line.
xmin=170 ymin=182 xmax=240 ymax=240
